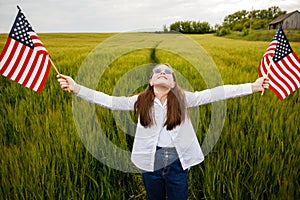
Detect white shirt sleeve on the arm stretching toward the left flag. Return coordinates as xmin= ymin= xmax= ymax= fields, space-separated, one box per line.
xmin=77 ymin=86 xmax=138 ymax=110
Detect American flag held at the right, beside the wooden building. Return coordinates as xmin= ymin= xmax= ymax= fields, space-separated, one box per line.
xmin=258 ymin=26 xmax=300 ymax=100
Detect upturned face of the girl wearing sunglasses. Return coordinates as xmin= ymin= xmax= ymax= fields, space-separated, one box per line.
xmin=149 ymin=64 xmax=176 ymax=88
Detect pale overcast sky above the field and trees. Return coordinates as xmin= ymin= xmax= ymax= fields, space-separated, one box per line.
xmin=0 ymin=0 xmax=300 ymax=33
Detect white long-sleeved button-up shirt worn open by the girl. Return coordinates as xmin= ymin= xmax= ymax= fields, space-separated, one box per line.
xmin=78 ymin=83 xmax=252 ymax=171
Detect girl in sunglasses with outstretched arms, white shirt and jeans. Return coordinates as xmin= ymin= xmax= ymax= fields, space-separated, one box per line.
xmin=57 ymin=64 xmax=269 ymax=200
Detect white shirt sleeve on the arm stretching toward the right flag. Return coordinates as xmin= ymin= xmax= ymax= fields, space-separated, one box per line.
xmin=185 ymin=83 xmax=253 ymax=107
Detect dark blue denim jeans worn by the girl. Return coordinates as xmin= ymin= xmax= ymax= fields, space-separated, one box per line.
xmin=142 ymin=147 xmax=188 ymax=200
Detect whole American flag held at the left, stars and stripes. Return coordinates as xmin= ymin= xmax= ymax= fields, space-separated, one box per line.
xmin=0 ymin=9 xmax=51 ymax=92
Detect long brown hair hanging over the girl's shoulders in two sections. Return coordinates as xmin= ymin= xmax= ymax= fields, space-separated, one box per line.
xmin=134 ymin=65 xmax=186 ymax=130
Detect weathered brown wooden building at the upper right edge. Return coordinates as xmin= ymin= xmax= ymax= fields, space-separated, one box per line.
xmin=269 ymin=10 xmax=300 ymax=30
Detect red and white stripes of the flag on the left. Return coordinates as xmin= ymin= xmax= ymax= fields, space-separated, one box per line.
xmin=0 ymin=38 xmax=50 ymax=92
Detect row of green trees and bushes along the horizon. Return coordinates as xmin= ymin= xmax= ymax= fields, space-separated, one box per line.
xmin=164 ymin=6 xmax=286 ymax=36
